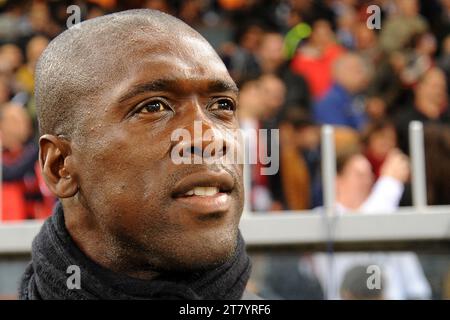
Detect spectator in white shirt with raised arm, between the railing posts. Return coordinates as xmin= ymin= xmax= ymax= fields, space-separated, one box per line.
xmin=312 ymin=147 xmax=431 ymax=299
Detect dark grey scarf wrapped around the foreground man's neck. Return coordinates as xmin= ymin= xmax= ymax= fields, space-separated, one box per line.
xmin=19 ymin=203 xmax=251 ymax=300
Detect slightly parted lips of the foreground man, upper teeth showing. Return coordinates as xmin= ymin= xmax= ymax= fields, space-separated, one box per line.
xmin=172 ymin=170 xmax=234 ymax=214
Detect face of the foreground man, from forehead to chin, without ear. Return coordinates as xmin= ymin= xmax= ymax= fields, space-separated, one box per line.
xmin=68 ymin=33 xmax=243 ymax=270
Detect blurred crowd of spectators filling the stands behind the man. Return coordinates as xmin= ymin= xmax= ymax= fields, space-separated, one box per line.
xmin=0 ymin=0 xmax=450 ymax=299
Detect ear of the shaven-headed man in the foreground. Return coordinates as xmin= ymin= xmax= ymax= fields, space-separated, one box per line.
xmin=39 ymin=134 xmax=78 ymax=198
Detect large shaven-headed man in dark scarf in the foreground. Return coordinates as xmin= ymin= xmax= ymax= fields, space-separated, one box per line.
xmin=20 ymin=10 xmax=250 ymax=299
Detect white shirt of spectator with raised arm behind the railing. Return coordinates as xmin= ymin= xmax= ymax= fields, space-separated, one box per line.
xmin=312 ymin=177 xmax=431 ymax=300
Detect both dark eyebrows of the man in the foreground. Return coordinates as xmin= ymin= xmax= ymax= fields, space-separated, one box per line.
xmin=119 ymin=79 xmax=239 ymax=102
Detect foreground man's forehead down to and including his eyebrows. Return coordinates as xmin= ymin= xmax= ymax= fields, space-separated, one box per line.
xmin=84 ymin=36 xmax=237 ymax=103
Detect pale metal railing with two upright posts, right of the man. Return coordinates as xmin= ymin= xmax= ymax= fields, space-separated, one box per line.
xmin=241 ymin=121 xmax=450 ymax=250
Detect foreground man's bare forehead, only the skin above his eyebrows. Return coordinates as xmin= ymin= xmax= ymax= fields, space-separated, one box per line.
xmin=76 ymin=27 xmax=228 ymax=82
